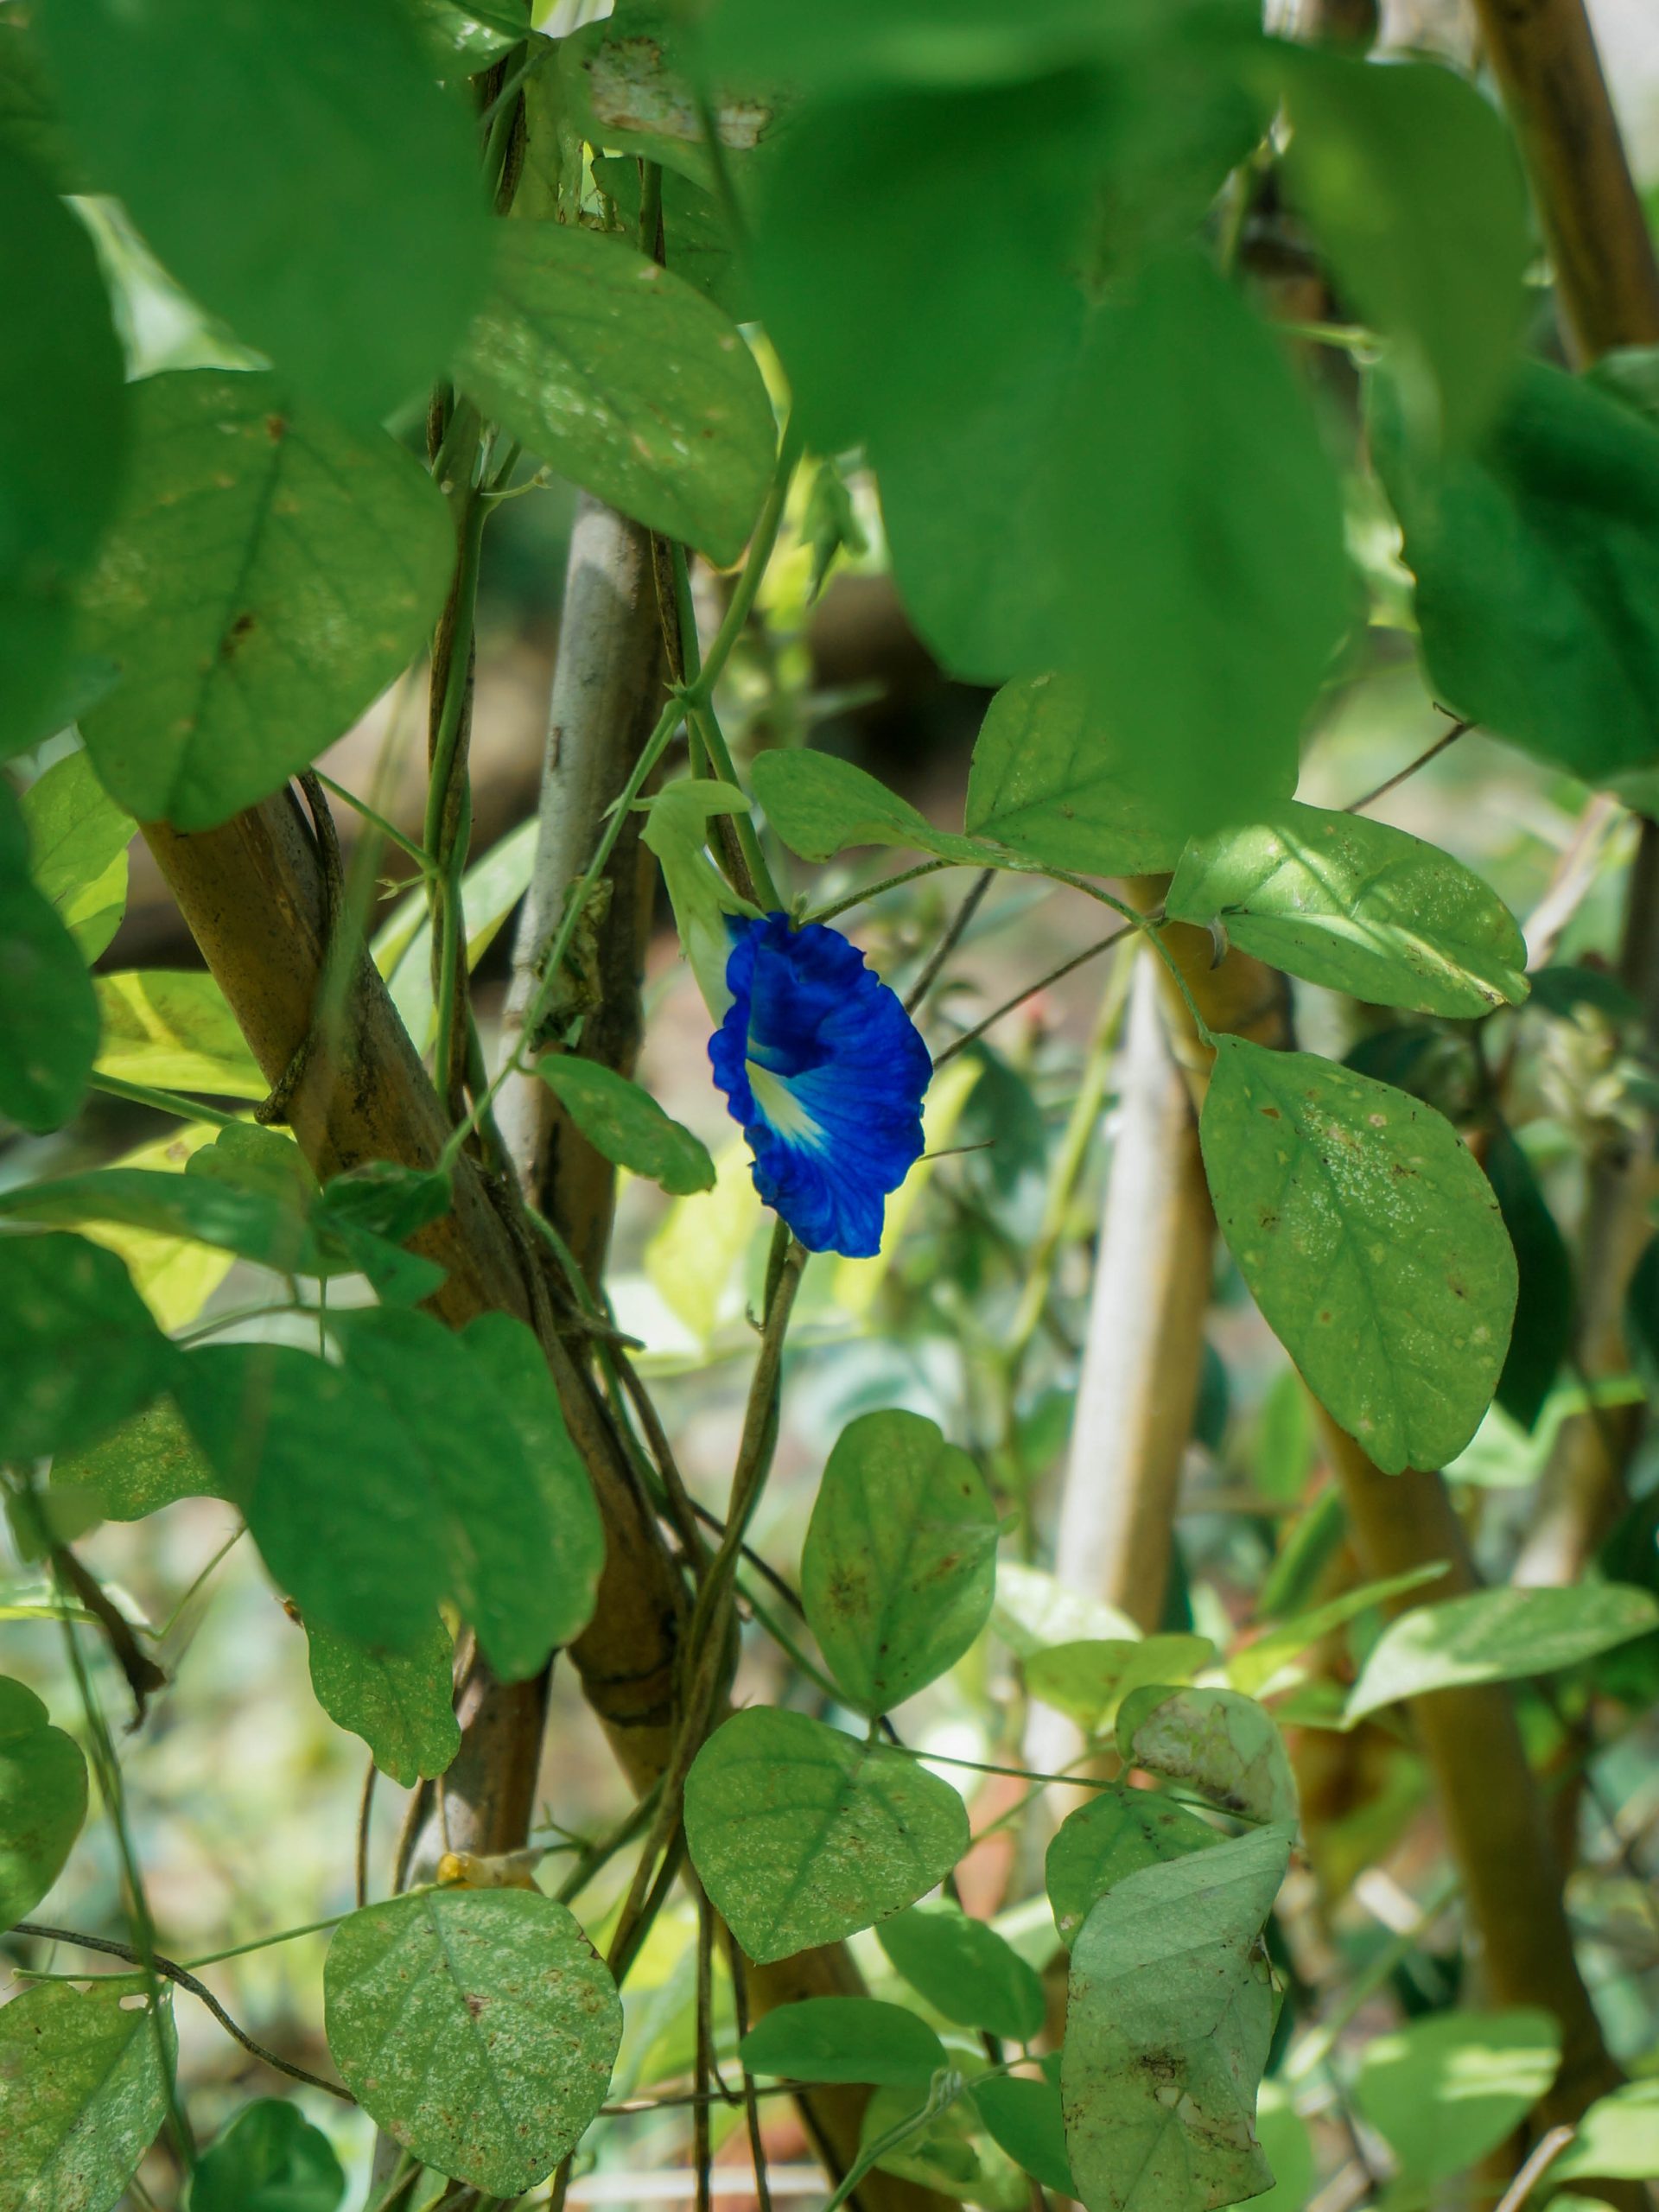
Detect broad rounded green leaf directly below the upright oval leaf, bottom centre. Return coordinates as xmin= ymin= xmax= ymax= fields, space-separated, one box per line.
xmin=686 ymin=1710 xmax=969 ymax=1964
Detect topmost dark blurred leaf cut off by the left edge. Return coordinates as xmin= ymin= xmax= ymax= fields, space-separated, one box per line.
xmin=0 ymin=143 xmax=128 ymax=761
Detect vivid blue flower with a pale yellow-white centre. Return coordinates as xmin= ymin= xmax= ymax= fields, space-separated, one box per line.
xmin=708 ymin=913 xmax=933 ymax=1259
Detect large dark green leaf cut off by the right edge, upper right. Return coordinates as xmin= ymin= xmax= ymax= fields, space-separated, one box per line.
xmin=1371 ymin=360 xmax=1659 ymax=783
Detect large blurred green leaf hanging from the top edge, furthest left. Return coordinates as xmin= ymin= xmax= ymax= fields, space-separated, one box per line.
xmin=38 ymin=0 xmax=486 ymax=420
